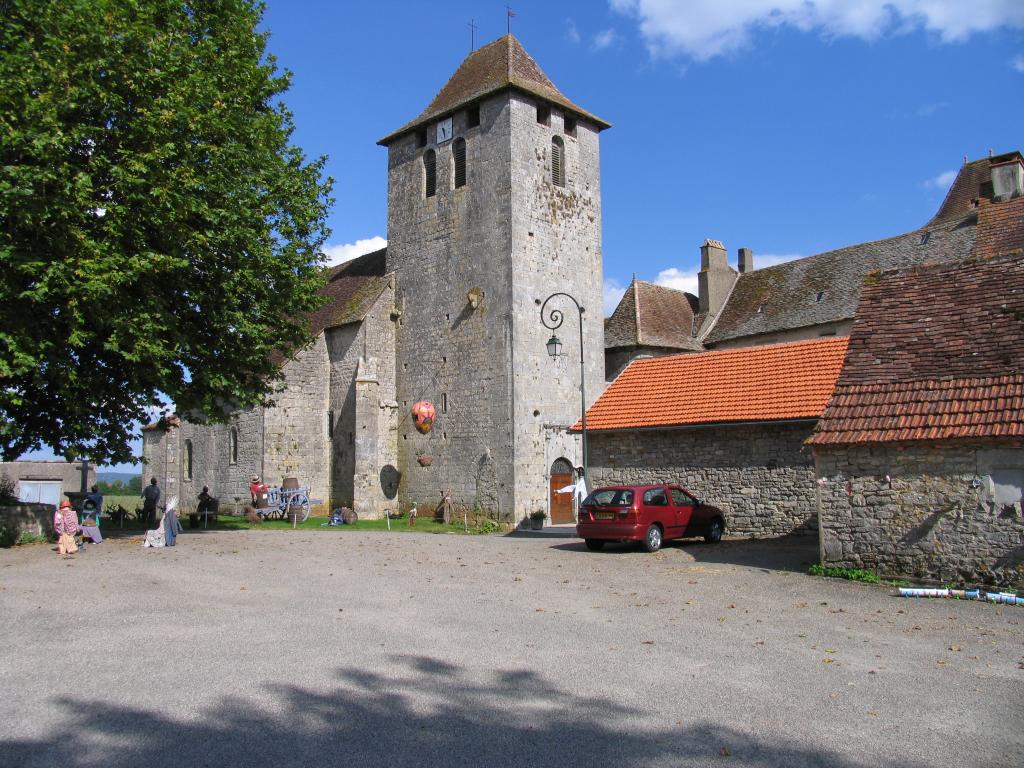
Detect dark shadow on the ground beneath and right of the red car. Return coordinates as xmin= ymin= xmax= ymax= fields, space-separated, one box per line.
xmin=552 ymin=536 xmax=818 ymax=573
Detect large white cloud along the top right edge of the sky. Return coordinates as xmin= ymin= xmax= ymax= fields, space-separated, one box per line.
xmin=609 ymin=0 xmax=1024 ymax=61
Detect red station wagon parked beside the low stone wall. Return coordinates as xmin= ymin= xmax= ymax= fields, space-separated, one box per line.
xmin=577 ymin=484 xmax=725 ymax=552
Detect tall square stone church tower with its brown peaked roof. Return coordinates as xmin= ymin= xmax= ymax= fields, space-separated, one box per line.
xmin=379 ymin=35 xmax=609 ymax=520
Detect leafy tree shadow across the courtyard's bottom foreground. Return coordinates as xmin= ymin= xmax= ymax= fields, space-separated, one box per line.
xmin=6 ymin=656 xmax=905 ymax=768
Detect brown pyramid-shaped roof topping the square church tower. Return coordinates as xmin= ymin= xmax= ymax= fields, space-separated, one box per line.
xmin=377 ymin=35 xmax=611 ymax=145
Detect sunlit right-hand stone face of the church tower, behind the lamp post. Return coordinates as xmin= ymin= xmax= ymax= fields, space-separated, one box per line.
xmin=510 ymin=94 xmax=605 ymax=519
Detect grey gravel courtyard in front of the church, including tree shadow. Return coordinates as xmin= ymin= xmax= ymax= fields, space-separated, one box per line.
xmin=0 ymin=530 xmax=1024 ymax=768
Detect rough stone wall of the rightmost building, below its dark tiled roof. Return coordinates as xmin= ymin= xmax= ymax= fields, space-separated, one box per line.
xmin=815 ymin=445 xmax=1024 ymax=585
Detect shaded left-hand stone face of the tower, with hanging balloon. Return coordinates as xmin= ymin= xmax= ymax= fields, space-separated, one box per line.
xmin=387 ymin=93 xmax=515 ymax=519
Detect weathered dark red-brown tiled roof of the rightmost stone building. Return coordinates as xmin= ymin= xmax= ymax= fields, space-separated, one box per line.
xmin=809 ymin=256 xmax=1024 ymax=445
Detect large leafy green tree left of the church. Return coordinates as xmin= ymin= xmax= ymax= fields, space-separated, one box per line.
xmin=0 ymin=0 xmax=331 ymax=462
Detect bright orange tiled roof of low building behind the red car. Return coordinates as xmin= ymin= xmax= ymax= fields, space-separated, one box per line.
xmin=577 ymin=337 xmax=847 ymax=430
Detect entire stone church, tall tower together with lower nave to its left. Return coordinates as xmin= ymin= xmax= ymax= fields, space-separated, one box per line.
xmin=143 ymin=36 xmax=608 ymax=521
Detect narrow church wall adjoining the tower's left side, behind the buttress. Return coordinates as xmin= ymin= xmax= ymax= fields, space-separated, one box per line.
xmin=327 ymin=283 xmax=396 ymax=509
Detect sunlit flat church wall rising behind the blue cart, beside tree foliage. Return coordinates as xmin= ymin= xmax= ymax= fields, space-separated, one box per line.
xmin=262 ymin=334 xmax=331 ymax=513
